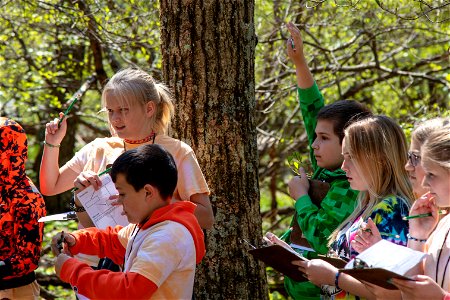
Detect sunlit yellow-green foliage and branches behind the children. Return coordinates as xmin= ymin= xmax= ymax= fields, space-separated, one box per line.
xmin=0 ymin=0 xmax=450 ymax=299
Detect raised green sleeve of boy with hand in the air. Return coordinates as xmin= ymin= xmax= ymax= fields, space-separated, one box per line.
xmin=297 ymin=82 xmax=324 ymax=170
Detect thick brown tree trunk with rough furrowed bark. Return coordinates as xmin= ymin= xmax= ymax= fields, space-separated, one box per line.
xmin=160 ymin=0 xmax=268 ymax=299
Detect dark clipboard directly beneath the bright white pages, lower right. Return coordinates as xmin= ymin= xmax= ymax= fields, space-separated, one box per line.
xmin=340 ymin=268 xmax=413 ymax=290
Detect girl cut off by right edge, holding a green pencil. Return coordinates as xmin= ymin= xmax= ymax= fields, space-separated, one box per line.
xmin=393 ymin=125 xmax=450 ymax=300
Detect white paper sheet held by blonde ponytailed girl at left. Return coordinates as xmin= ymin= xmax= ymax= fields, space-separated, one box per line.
xmin=77 ymin=174 xmax=128 ymax=229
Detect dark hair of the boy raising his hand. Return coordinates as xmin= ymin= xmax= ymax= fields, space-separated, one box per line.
xmin=317 ymin=100 xmax=372 ymax=143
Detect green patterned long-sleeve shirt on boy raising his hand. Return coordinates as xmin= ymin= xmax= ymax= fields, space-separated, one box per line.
xmin=285 ymin=83 xmax=358 ymax=299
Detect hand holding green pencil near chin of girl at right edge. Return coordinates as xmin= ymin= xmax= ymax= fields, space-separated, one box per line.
xmin=409 ymin=193 xmax=439 ymax=240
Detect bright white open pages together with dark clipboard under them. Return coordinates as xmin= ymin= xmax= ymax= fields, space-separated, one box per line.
xmin=341 ymin=240 xmax=426 ymax=290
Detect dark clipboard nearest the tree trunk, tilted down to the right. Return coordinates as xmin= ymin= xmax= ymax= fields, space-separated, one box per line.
xmin=248 ymin=245 xmax=308 ymax=282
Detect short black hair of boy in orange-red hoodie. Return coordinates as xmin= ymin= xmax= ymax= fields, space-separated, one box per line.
xmin=111 ymin=144 xmax=178 ymax=199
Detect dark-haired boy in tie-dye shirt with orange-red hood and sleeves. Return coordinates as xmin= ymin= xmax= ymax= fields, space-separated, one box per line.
xmin=52 ymin=144 xmax=205 ymax=299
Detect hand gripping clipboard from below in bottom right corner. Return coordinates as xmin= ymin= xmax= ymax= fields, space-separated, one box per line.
xmin=392 ymin=275 xmax=446 ymax=300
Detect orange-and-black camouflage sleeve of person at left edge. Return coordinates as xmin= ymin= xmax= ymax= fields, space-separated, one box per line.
xmin=0 ymin=193 xmax=45 ymax=278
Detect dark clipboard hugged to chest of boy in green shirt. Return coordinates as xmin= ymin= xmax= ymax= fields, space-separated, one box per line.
xmin=289 ymin=179 xmax=330 ymax=248
